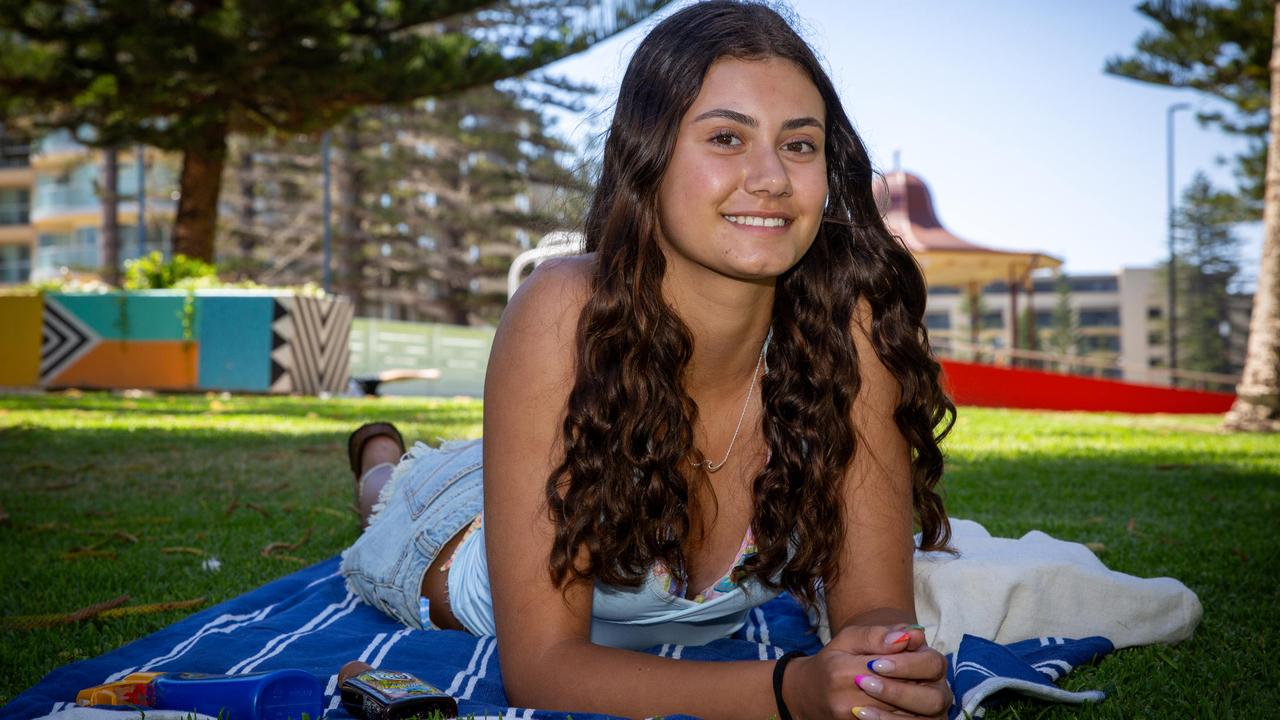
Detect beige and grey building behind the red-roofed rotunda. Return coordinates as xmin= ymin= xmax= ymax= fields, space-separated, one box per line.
xmin=925 ymin=268 xmax=1253 ymax=384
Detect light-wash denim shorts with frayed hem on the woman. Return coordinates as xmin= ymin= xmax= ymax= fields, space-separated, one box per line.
xmin=340 ymin=439 xmax=484 ymax=629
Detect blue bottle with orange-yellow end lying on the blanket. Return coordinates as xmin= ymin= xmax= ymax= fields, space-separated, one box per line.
xmin=76 ymin=670 xmax=324 ymax=720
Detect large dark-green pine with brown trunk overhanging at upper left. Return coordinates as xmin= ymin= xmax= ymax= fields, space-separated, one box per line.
xmin=0 ymin=0 xmax=667 ymax=260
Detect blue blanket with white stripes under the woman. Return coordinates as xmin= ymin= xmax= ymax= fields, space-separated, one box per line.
xmin=0 ymin=557 xmax=1112 ymax=720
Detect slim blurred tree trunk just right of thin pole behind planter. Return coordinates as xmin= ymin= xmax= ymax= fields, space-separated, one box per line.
xmin=335 ymin=113 xmax=367 ymax=312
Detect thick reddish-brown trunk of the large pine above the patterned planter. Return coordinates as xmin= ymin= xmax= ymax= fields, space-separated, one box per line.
xmin=173 ymin=124 xmax=227 ymax=263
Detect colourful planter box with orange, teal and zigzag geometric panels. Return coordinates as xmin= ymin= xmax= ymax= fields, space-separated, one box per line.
xmin=0 ymin=290 xmax=352 ymax=395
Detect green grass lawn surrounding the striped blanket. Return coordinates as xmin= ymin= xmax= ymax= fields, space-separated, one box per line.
xmin=0 ymin=393 xmax=1280 ymax=720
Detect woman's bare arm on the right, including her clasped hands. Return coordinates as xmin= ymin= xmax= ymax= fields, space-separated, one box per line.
xmin=768 ymin=301 xmax=951 ymax=717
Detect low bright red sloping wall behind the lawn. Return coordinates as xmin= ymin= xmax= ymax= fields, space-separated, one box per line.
xmin=942 ymin=360 xmax=1235 ymax=413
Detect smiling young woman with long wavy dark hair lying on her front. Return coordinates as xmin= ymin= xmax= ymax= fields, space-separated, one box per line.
xmin=343 ymin=0 xmax=955 ymax=720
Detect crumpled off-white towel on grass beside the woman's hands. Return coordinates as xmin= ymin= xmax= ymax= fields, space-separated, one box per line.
xmin=818 ymin=518 xmax=1203 ymax=655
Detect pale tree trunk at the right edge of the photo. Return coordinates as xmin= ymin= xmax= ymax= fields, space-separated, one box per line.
xmin=1222 ymin=13 xmax=1280 ymax=432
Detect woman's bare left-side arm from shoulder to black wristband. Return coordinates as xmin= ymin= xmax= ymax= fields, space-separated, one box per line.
xmin=484 ymin=259 xmax=790 ymax=720
